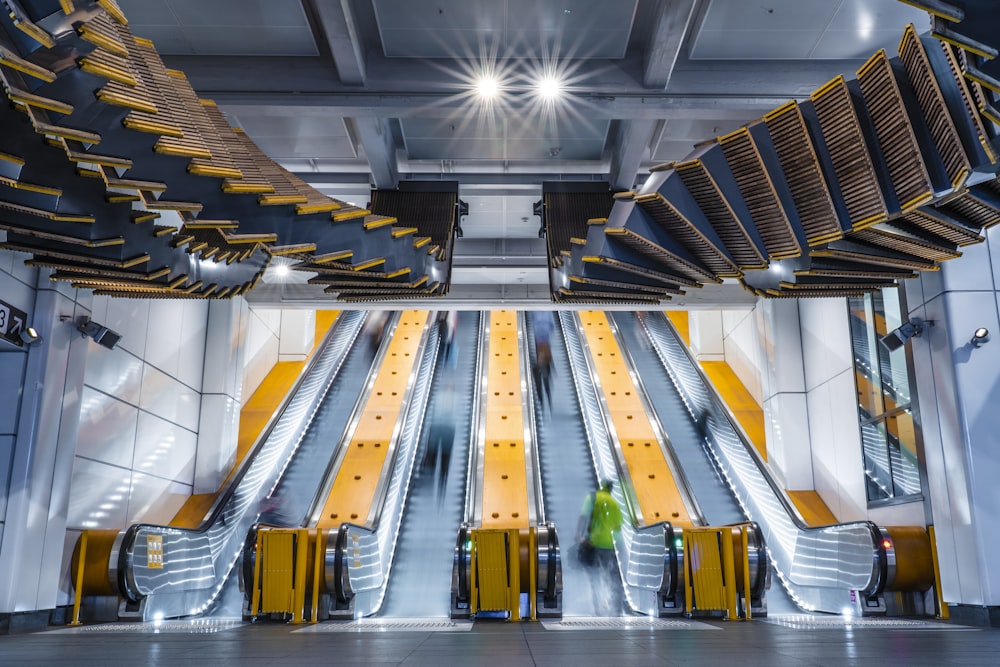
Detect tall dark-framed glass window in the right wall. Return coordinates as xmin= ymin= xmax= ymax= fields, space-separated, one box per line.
xmin=848 ymin=289 xmax=920 ymax=502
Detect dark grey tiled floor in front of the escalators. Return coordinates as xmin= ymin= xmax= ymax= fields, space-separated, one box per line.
xmin=0 ymin=618 xmax=1000 ymax=667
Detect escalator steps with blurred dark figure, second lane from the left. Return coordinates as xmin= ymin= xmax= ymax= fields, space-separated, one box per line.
xmin=379 ymin=311 xmax=481 ymax=618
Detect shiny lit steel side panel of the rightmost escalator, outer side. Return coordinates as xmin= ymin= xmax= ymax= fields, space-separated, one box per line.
xmin=645 ymin=314 xmax=880 ymax=613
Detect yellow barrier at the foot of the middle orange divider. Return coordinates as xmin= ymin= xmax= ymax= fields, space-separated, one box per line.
xmin=469 ymin=528 xmax=538 ymax=621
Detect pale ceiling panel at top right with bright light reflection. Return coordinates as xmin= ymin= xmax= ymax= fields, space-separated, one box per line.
xmin=690 ymin=0 xmax=927 ymax=60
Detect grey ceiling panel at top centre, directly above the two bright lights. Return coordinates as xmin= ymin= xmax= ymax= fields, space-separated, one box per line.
xmin=373 ymin=0 xmax=637 ymax=60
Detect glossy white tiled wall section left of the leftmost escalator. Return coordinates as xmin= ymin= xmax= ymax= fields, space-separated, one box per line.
xmin=68 ymin=297 xmax=208 ymax=529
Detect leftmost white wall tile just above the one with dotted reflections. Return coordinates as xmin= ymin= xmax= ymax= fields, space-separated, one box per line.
xmin=76 ymin=386 xmax=139 ymax=468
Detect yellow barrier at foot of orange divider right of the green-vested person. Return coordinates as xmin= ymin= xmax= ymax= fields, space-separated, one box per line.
xmin=684 ymin=526 xmax=751 ymax=620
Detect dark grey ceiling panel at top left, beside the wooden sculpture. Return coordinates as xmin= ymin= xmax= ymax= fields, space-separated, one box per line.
xmin=119 ymin=0 xmax=319 ymax=56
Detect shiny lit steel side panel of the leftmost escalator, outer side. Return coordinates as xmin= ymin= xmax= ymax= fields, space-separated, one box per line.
xmin=116 ymin=313 xmax=363 ymax=620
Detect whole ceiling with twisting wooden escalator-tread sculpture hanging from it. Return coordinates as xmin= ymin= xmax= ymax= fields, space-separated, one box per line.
xmin=0 ymin=0 xmax=1000 ymax=307
